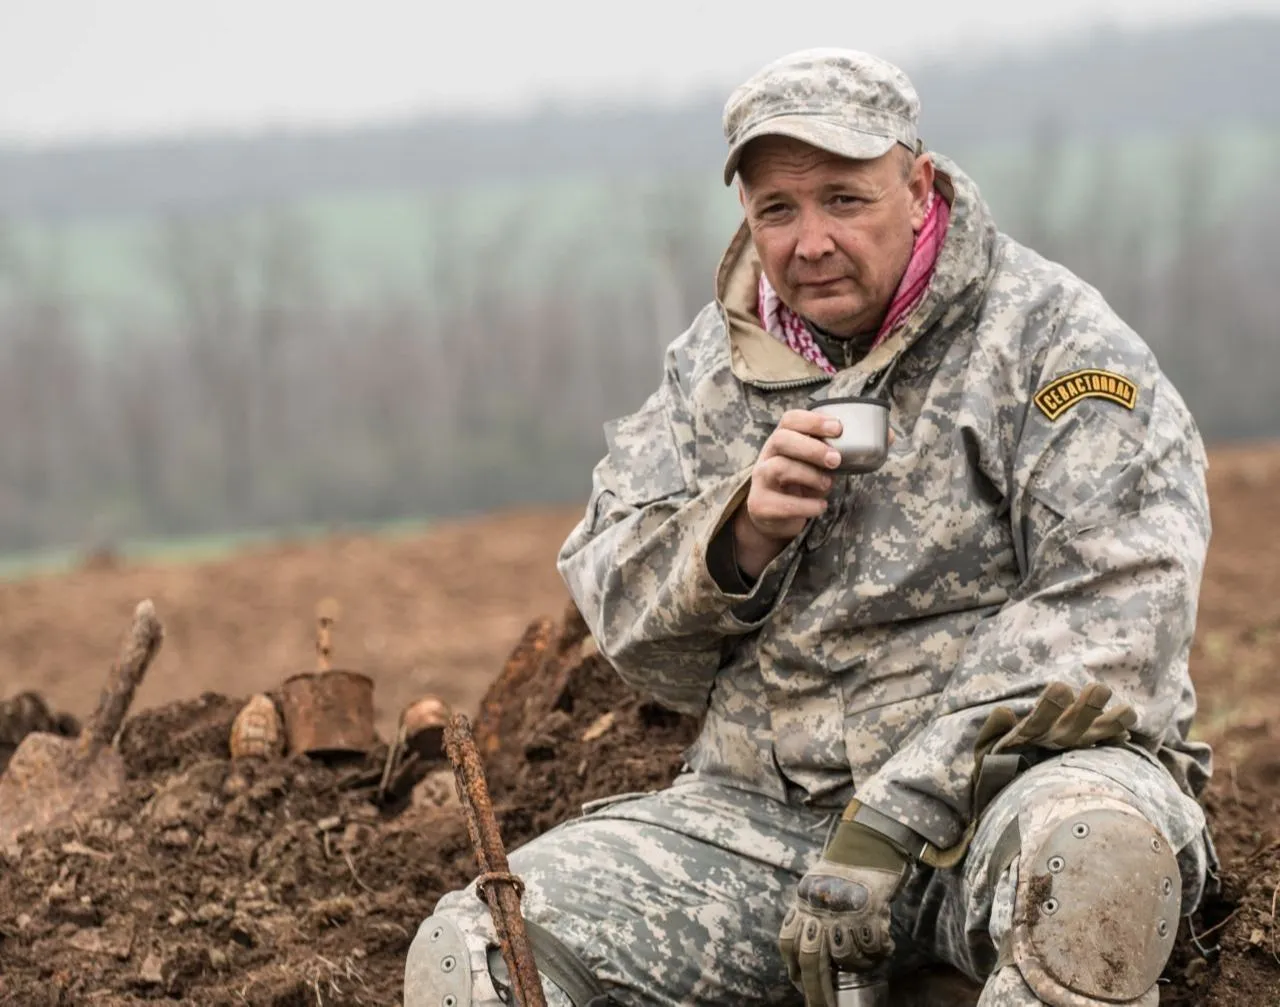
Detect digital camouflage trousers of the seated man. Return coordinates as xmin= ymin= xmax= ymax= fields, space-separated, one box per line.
xmin=404 ymin=749 xmax=1207 ymax=1007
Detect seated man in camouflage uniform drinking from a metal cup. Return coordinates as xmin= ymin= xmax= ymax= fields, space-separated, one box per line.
xmin=406 ymin=50 xmax=1212 ymax=1007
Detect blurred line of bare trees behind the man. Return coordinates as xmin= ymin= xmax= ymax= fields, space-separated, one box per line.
xmin=0 ymin=131 xmax=1280 ymax=553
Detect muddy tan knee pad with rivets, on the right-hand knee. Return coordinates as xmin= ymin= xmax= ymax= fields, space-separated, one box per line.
xmin=1010 ymin=807 xmax=1181 ymax=1007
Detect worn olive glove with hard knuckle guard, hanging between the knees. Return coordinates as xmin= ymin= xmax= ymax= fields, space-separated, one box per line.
xmin=778 ymin=811 xmax=910 ymax=1007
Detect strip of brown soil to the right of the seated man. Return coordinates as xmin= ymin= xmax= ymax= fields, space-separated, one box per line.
xmin=1161 ymin=447 xmax=1280 ymax=1007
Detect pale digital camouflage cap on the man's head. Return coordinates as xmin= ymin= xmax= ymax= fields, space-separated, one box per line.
xmin=724 ymin=49 xmax=920 ymax=186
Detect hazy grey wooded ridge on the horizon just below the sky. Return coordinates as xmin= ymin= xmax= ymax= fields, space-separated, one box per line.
xmin=0 ymin=19 xmax=1280 ymax=219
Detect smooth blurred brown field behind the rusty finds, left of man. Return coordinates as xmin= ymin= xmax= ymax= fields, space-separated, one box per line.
xmin=0 ymin=508 xmax=581 ymax=737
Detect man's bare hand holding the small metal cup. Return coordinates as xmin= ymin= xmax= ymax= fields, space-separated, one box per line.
xmin=733 ymin=409 xmax=840 ymax=578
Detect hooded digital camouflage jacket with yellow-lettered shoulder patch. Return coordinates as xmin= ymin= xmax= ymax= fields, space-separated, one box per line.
xmin=559 ymin=157 xmax=1210 ymax=847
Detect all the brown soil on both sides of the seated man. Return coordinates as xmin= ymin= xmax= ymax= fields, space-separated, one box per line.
xmin=0 ymin=448 xmax=1280 ymax=1007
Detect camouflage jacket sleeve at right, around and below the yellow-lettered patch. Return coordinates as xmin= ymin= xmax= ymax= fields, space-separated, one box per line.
xmin=858 ymin=330 xmax=1210 ymax=847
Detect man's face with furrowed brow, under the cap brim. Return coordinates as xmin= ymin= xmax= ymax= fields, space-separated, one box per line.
xmin=740 ymin=137 xmax=933 ymax=335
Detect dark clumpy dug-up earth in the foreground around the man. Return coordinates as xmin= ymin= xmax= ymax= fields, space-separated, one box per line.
xmin=0 ymin=608 xmax=1280 ymax=1007
